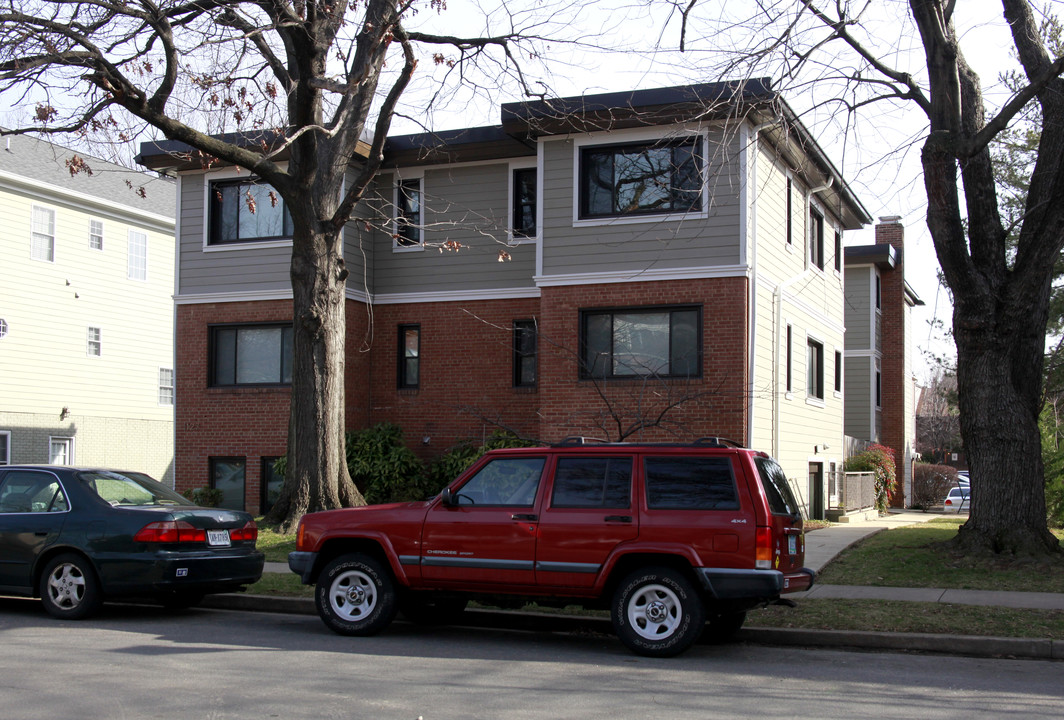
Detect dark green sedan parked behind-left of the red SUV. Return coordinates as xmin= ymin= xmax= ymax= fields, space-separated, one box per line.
xmin=0 ymin=465 xmax=265 ymax=620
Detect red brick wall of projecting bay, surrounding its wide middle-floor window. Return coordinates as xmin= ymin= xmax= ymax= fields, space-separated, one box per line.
xmin=539 ymin=278 xmax=749 ymax=442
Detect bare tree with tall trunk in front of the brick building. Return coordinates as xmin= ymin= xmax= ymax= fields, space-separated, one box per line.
xmin=0 ymin=0 xmax=566 ymax=530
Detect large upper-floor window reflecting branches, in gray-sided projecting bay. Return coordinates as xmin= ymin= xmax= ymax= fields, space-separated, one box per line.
xmin=580 ymin=137 xmax=702 ymax=218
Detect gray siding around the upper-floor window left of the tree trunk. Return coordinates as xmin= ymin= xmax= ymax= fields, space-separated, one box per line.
xmin=178 ymin=174 xmax=292 ymax=296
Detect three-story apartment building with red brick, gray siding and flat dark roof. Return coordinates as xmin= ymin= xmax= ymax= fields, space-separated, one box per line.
xmin=140 ymin=81 xmax=871 ymax=517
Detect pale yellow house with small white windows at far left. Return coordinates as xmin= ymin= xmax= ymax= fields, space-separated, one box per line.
xmin=0 ymin=135 xmax=174 ymax=482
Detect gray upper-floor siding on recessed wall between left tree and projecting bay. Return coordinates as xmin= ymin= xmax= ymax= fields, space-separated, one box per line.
xmin=373 ymin=163 xmax=535 ymax=295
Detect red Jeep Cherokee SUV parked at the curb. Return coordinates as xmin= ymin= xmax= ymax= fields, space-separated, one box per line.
xmin=288 ymin=438 xmax=814 ymax=656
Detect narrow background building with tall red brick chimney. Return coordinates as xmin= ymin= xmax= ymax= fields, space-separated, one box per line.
xmin=845 ymin=216 xmax=924 ymax=507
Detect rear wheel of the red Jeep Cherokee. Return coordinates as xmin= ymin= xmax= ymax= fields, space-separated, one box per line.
xmin=611 ymin=567 xmax=705 ymax=657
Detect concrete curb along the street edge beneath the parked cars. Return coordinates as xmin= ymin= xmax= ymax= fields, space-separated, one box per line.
xmin=200 ymin=593 xmax=1064 ymax=660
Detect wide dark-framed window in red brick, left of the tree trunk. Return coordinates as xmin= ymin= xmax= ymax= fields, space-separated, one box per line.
xmin=210 ymin=325 xmax=293 ymax=386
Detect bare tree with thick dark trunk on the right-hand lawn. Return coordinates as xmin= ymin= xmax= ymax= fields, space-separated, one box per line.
xmin=670 ymin=0 xmax=1064 ymax=554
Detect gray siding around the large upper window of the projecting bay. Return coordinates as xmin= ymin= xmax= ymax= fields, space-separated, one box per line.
xmin=542 ymin=131 xmax=741 ymax=277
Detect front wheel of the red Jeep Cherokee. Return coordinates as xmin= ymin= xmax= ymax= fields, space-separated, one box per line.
xmin=314 ymin=553 xmax=396 ymax=635
